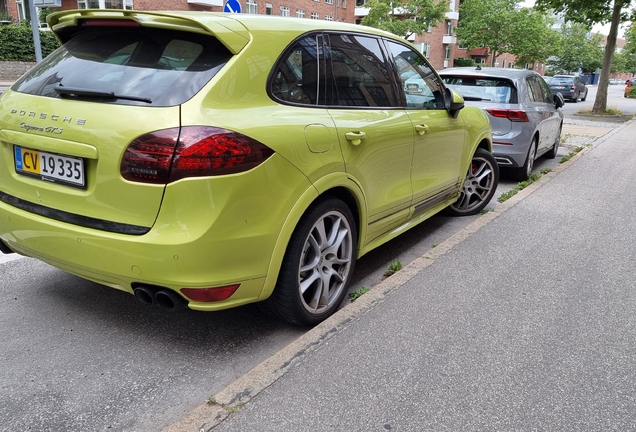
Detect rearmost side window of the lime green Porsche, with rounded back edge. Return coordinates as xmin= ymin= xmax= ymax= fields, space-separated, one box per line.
xmin=270 ymin=35 xmax=324 ymax=105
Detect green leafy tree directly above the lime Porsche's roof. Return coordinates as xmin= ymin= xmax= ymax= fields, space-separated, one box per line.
xmin=362 ymin=0 xmax=449 ymax=38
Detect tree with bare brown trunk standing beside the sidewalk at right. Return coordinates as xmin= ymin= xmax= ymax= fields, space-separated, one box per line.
xmin=535 ymin=0 xmax=632 ymax=114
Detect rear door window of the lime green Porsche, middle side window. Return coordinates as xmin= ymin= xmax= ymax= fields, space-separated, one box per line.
xmin=325 ymin=34 xmax=399 ymax=107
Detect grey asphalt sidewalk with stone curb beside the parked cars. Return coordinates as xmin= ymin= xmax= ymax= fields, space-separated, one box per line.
xmin=166 ymin=121 xmax=636 ymax=432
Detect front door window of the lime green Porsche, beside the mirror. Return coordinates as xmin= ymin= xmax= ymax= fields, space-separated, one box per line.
xmin=387 ymin=41 xmax=444 ymax=108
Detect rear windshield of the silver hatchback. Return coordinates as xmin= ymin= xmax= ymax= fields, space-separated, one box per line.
xmin=442 ymin=75 xmax=517 ymax=103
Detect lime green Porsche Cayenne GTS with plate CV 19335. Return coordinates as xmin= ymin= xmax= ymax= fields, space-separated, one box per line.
xmin=0 ymin=10 xmax=499 ymax=325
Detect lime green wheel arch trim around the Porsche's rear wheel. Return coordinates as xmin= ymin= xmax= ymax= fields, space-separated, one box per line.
xmin=258 ymin=173 xmax=367 ymax=301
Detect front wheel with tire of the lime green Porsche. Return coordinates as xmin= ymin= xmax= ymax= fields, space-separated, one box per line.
xmin=445 ymin=148 xmax=499 ymax=216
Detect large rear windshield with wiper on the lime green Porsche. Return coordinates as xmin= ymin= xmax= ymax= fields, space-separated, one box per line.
xmin=12 ymin=27 xmax=231 ymax=106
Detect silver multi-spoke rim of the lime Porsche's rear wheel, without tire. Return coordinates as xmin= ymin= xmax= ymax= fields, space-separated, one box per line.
xmin=298 ymin=211 xmax=354 ymax=314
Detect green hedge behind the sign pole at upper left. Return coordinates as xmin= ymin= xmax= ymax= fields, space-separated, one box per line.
xmin=0 ymin=21 xmax=60 ymax=61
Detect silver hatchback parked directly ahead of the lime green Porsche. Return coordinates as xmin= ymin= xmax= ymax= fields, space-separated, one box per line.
xmin=440 ymin=68 xmax=563 ymax=180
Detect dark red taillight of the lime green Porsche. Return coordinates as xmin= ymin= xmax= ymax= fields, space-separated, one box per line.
xmin=121 ymin=126 xmax=274 ymax=184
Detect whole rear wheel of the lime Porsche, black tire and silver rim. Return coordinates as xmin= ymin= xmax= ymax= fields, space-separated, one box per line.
xmin=260 ymin=198 xmax=358 ymax=326
